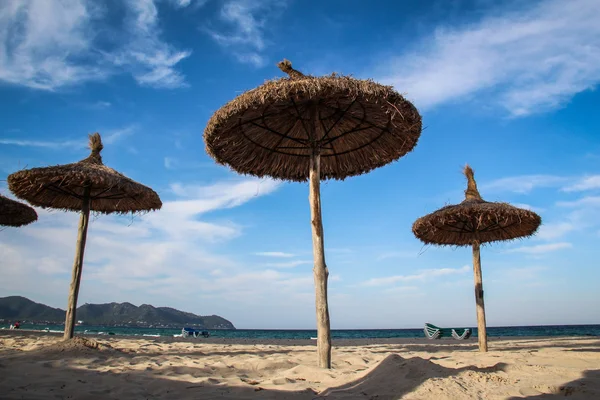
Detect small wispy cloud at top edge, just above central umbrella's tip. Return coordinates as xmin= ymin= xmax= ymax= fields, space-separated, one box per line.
xmin=206 ymin=0 xmax=286 ymax=67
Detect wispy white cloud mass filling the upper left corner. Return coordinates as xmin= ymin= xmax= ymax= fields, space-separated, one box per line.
xmin=0 ymin=0 xmax=191 ymax=90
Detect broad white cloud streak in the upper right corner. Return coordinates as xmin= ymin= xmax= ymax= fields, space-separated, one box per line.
xmin=379 ymin=0 xmax=600 ymax=116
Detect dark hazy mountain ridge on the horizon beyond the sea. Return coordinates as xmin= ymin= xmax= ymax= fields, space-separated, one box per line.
xmin=0 ymin=296 xmax=235 ymax=329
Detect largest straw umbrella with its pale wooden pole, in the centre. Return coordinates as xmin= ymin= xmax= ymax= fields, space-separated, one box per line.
xmin=204 ymin=60 xmax=421 ymax=368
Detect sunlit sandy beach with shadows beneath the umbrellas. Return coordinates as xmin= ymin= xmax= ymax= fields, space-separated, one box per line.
xmin=0 ymin=331 xmax=600 ymax=399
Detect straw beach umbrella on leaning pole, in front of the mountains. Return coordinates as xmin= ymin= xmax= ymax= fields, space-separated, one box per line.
xmin=8 ymin=133 xmax=162 ymax=339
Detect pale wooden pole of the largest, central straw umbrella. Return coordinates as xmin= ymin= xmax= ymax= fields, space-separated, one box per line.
xmin=308 ymin=105 xmax=331 ymax=368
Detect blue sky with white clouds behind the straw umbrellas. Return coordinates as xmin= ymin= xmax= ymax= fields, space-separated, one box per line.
xmin=0 ymin=0 xmax=600 ymax=328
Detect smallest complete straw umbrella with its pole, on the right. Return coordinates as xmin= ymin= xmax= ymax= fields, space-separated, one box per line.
xmin=412 ymin=165 xmax=542 ymax=351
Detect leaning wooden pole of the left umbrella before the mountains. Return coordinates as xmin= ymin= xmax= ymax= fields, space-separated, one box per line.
xmin=64 ymin=186 xmax=91 ymax=339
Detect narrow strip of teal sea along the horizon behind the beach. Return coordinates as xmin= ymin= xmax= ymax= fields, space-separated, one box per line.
xmin=0 ymin=324 xmax=600 ymax=340
